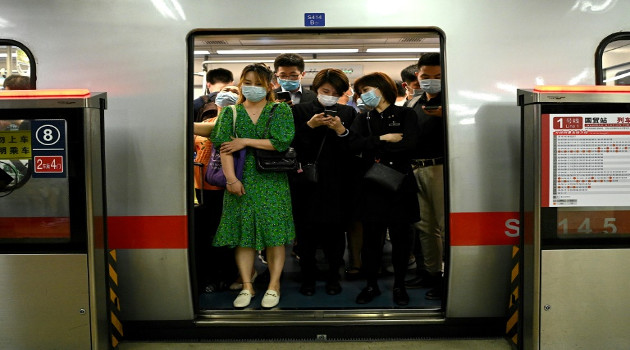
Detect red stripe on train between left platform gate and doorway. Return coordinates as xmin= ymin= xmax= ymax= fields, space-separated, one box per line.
xmin=107 ymin=216 xmax=188 ymax=249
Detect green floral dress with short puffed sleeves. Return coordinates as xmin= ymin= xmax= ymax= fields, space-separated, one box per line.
xmin=210 ymin=103 xmax=295 ymax=250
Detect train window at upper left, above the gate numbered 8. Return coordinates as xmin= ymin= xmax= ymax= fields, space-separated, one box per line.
xmin=0 ymin=39 xmax=36 ymax=90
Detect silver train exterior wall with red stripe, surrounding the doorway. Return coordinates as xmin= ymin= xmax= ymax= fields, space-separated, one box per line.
xmin=0 ymin=0 xmax=630 ymax=328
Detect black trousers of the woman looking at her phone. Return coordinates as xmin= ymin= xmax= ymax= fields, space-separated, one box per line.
xmin=298 ymin=222 xmax=346 ymax=282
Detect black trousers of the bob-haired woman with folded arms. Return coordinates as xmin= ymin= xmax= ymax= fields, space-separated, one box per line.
xmin=361 ymin=221 xmax=412 ymax=286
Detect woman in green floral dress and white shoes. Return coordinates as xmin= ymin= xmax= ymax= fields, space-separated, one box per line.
xmin=210 ymin=64 xmax=295 ymax=308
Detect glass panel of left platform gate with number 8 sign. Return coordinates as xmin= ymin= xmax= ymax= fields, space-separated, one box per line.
xmin=0 ymin=119 xmax=71 ymax=243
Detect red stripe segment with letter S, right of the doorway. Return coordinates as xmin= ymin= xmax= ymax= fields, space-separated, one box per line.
xmin=450 ymin=212 xmax=519 ymax=246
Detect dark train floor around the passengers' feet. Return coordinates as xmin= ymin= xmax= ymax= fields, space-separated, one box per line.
xmin=199 ymin=241 xmax=441 ymax=312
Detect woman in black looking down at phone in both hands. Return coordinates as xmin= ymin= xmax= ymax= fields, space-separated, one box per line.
xmin=293 ymin=68 xmax=356 ymax=296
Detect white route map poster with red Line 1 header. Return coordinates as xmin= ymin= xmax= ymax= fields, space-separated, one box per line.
xmin=541 ymin=113 xmax=630 ymax=207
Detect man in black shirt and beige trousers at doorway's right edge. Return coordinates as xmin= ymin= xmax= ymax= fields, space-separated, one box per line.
xmin=406 ymin=53 xmax=444 ymax=299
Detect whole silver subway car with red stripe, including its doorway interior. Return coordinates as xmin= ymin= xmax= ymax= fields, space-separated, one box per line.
xmin=0 ymin=0 xmax=630 ymax=346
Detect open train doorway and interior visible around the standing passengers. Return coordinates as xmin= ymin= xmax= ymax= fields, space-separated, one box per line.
xmin=188 ymin=29 xmax=449 ymax=330
